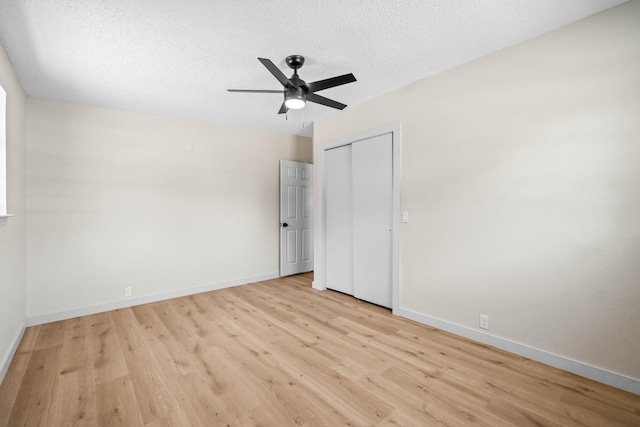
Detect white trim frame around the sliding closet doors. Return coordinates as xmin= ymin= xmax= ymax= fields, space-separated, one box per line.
xmin=313 ymin=123 xmax=401 ymax=312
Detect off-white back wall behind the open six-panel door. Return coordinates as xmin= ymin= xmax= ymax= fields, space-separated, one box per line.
xmin=27 ymin=98 xmax=312 ymax=317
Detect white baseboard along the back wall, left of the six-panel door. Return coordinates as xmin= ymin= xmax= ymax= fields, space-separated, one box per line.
xmin=27 ymin=273 xmax=280 ymax=326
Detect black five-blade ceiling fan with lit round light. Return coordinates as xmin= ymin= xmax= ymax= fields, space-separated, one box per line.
xmin=227 ymin=55 xmax=356 ymax=114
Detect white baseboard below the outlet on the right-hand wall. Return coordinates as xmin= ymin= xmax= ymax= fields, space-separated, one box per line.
xmin=393 ymin=308 xmax=640 ymax=395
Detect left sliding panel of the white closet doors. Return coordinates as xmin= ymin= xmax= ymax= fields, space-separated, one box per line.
xmin=325 ymin=145 xmax=354 ymax=295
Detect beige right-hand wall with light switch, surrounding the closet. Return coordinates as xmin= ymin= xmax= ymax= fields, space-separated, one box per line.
xmin=314 ymin=1 xmax=640 ymax=379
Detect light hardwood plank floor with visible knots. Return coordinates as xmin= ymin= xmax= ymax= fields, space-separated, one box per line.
xmin=0 ymin=274 xmax=640 ymax=427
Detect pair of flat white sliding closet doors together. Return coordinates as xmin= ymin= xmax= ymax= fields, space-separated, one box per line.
xmin=324 ymin=133 xmax=393 ymax=307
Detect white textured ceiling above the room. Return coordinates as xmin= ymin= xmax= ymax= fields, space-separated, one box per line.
xmin=0 ymin=0 xmax=624 ymax=135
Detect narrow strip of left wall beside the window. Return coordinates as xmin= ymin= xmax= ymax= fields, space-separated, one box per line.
xmin=0 ymin=45 xmax=27 ymax=371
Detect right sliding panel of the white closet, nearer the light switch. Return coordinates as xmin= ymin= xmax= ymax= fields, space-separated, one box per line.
xmin=352 ymin=133 xmax=393 ymax=307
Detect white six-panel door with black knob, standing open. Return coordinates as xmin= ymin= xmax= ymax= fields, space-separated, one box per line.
xmin=280 ymin=160 xmax=313 ymax=276
